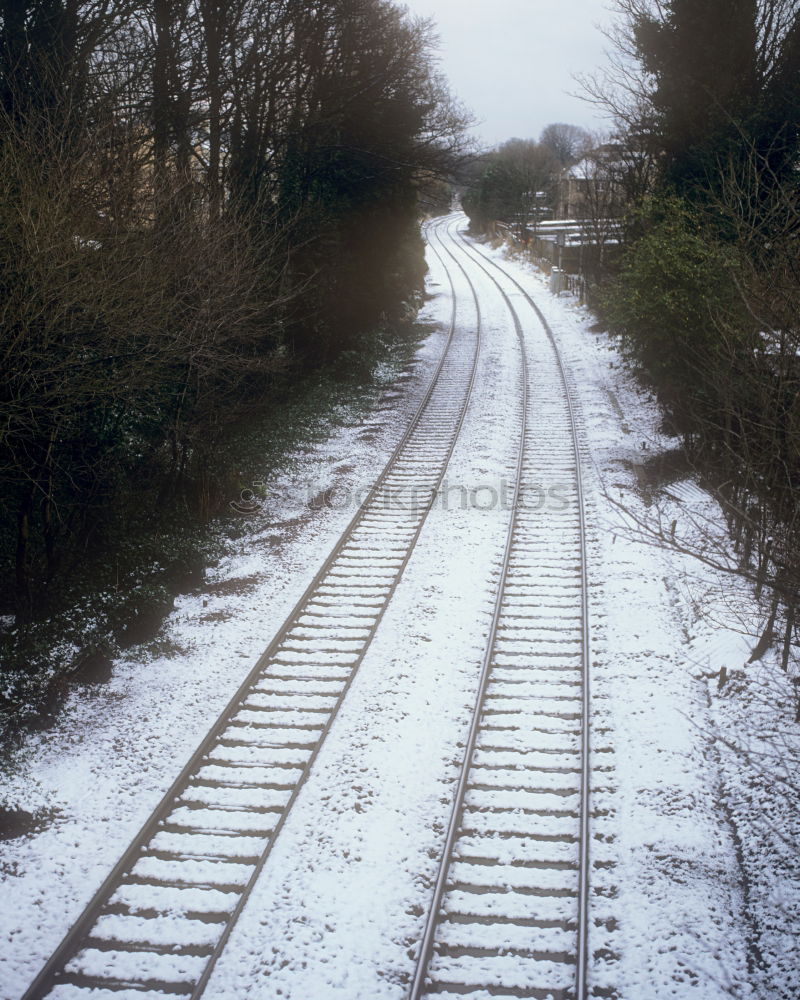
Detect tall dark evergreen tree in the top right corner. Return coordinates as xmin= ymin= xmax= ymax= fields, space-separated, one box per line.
xmin=629 ymin=0 xmax=800 ymax=198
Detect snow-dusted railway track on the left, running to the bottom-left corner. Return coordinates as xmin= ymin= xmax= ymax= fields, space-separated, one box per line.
xmin=18 ymin=218 xmax=480 ymax=1000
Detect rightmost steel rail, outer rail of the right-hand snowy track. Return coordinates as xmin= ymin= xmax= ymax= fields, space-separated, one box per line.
xmin=459 ymin=225 xmax=592 ymax=1000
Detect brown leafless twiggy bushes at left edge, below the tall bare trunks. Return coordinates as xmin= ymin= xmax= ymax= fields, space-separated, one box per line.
xmin=0 ymin=111 xmax=283 ymax=621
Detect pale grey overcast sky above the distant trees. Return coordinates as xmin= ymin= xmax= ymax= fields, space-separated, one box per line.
xmin=401 ymin=0 xmax=612 ymax=145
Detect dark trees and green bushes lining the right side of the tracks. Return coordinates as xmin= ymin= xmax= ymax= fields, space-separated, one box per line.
xmin=587 ymin=0 xmax=800 ymax=688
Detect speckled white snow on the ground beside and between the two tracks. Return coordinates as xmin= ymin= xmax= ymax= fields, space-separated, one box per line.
xmin=0 ymin=221 xmax=800 ymax=1000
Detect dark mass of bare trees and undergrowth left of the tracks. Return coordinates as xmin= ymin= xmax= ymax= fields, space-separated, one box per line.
xmin=0 ymin=0 xmax=465 ymax=720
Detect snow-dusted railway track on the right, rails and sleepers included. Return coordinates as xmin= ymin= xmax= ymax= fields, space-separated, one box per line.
xmin=408 ymin=223 xmax=599 ymax=1000
